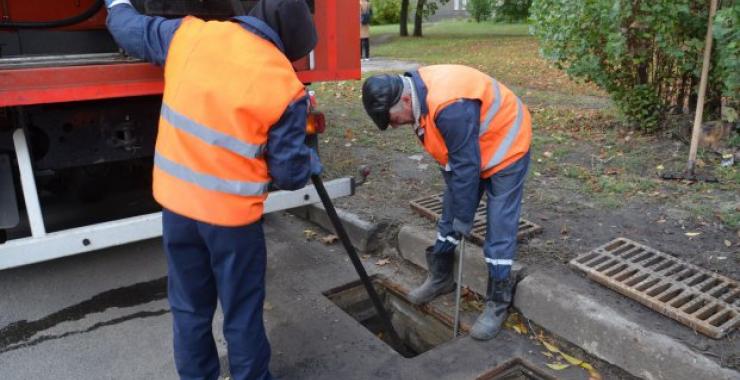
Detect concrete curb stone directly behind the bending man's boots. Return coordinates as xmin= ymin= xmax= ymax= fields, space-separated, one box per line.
xmin=398 ymin=226 xmax=524 ymax=296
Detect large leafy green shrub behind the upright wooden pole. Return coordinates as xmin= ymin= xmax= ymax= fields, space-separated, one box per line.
xmin=531 ymin=0 xmax=740 ymax=131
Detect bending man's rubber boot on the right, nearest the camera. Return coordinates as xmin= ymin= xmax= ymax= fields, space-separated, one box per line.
xmin=470 ymin=278 xmax=514 ymax=340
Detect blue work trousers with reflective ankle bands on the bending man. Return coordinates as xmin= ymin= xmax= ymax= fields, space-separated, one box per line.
xmin=433 ymin=153 xmax=529 ymax=280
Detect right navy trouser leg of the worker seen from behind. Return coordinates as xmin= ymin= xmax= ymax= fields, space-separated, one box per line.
xmin=200 ymin=221 xmax=272 ymax=380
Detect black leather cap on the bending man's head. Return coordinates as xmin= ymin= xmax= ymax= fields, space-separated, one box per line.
xmin=362 ymin=74 xmax=403 ymax=131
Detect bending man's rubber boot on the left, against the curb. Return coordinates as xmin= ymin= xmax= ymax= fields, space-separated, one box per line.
xmin=409 ymin=247 xmax=455 ymax=305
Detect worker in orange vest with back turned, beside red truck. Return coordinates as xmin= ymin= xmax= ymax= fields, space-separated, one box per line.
xmin=106 ymin=0 xmax=321 ymax=379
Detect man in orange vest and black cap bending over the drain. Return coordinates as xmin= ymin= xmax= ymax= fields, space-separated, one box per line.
xmin=362 ymin=65 xmax=532 ymax=340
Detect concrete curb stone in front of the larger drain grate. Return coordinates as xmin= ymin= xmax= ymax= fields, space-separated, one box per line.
xmin=514 ymin=272 xmax=738 ymax=380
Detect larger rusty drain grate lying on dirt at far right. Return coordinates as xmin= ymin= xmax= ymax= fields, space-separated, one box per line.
xmin=570 ymin=238 xmax=740 ymax=339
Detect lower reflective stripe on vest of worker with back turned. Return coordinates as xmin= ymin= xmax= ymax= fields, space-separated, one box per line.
xmin=154 ymin=152 xmax=268 ymax=196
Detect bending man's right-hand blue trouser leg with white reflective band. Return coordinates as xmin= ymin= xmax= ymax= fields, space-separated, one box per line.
xmin=483 ymin=153 xmax=529 ymax=281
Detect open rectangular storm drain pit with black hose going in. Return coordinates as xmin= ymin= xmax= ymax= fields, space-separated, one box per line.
xmin=324 ymin=277 xmax=460 ymax=358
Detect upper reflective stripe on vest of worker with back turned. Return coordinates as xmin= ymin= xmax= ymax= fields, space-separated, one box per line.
xmin=161 ymin=102 xmax=265 ymax=158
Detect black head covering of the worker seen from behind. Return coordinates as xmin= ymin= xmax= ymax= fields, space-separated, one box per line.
xmin=249 ymin=0 xmax=318 ymax=61
